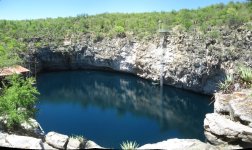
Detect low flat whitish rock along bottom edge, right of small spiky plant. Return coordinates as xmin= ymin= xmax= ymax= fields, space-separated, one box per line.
xmin=138 ymin=139 xmax=241 ymax=150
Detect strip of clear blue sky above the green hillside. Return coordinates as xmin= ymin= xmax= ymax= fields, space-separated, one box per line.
xmin=0 ymin=0 xmax=246 ymax=20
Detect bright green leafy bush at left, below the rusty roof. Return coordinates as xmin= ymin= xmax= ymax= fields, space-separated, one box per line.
xmin=0 ymin=75 xmax=39 ymax=129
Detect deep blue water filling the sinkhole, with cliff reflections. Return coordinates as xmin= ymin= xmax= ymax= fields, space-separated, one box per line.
xmin=36 ymin=70 xmax=213 ymax=148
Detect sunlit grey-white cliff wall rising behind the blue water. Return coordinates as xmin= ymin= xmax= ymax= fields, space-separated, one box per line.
xmin=28 ymin=26 xmax=252 ymax=94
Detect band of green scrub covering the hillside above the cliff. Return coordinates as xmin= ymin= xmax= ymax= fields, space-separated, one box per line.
xmin=0 ymin=1 xmax=252 ymax=52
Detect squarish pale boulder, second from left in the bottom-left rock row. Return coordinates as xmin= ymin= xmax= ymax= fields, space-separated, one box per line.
xmin=45 ymin=132 xmax=69 ymax=149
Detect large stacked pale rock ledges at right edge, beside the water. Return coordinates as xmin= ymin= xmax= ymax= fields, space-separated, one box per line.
xmin=204 ymin=89 xmax=252 ymax=147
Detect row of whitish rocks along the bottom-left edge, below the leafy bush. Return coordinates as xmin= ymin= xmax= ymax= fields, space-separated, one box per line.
xmin=0 ymin=132 xmax=102 ymax=149
